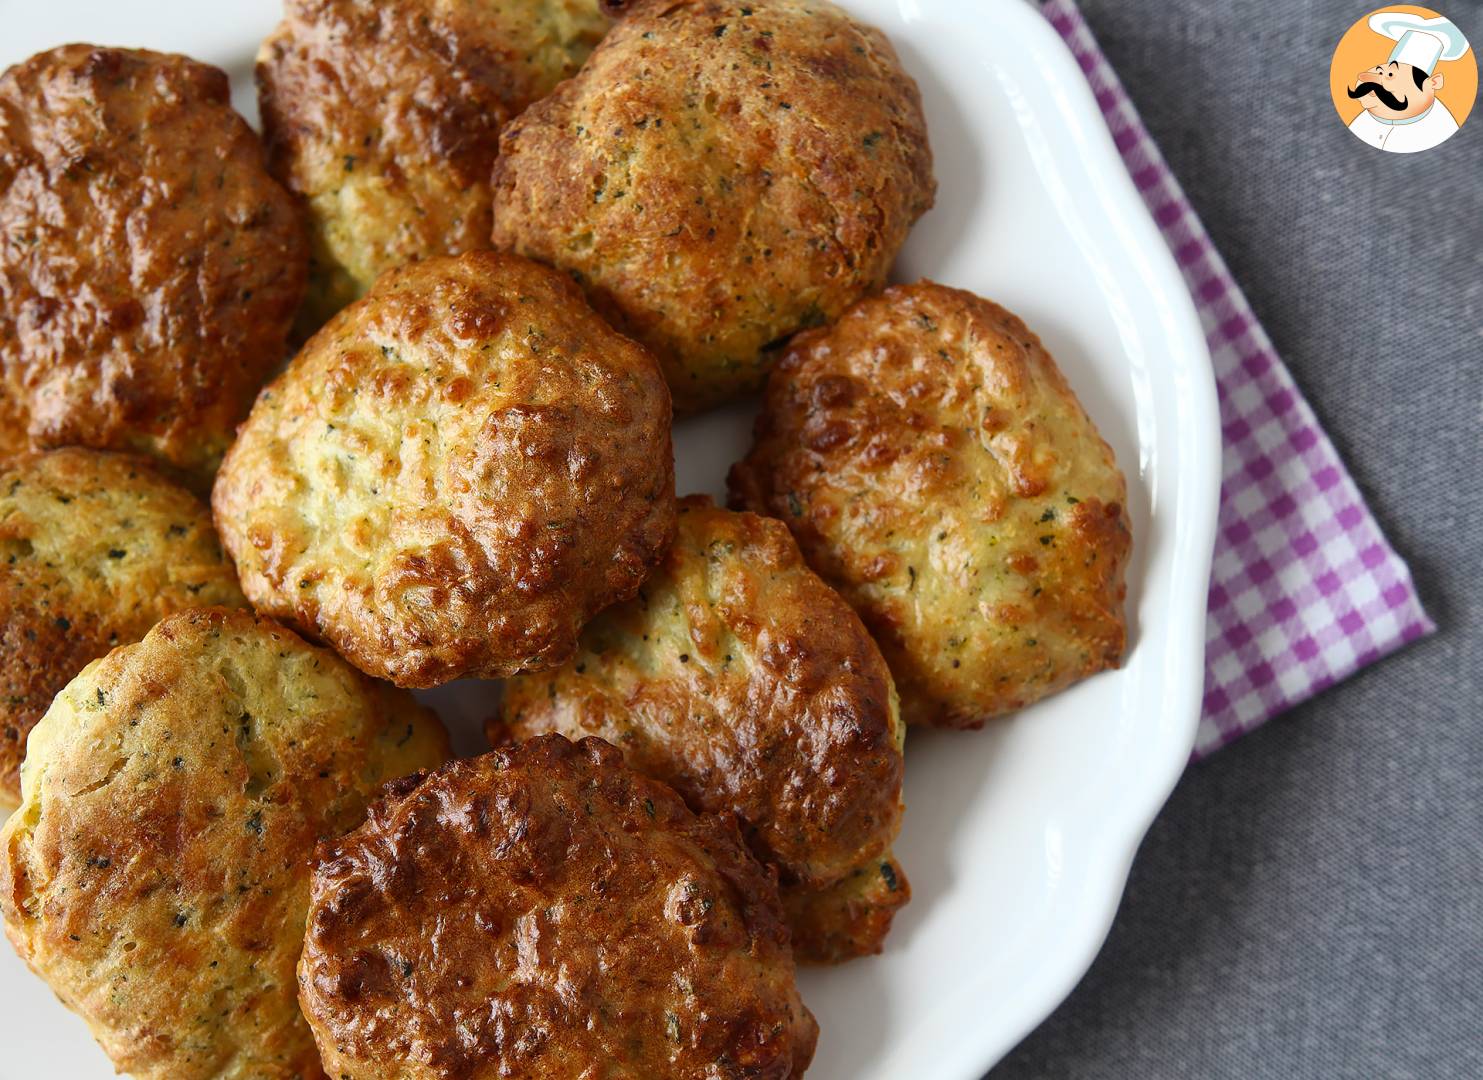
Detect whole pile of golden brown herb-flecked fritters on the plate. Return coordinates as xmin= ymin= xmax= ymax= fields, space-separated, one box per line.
xmin=0 ymin=0 xmax=1129 ymax=1080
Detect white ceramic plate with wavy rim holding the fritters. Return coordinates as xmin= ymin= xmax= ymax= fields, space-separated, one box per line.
xmin=0 ymin=0 xmax=1219 ymax=1080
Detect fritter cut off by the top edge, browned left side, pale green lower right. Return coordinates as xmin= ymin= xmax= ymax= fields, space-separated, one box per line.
xmin=257 ymin=0 xmax=608 ymax=331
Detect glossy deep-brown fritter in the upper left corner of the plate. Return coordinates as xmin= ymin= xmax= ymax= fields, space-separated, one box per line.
xmin=0 ymin=45 xmax=307 ymax=487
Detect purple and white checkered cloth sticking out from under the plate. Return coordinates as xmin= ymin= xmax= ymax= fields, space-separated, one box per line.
xmin=1043 ymin=0 xmax=1436 ymax=758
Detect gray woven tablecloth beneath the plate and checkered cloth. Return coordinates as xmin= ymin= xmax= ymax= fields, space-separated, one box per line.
xmin=991 ymin=0 xmax=1483 ymax=1080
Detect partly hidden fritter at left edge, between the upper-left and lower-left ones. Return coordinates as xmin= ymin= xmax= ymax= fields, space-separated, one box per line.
xmin=0 ymin=448 xmax=246 ymax=809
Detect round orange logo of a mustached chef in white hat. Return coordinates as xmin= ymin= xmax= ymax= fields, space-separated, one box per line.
xmin=1329 ymin=4 xmax=1479 ymax=154
